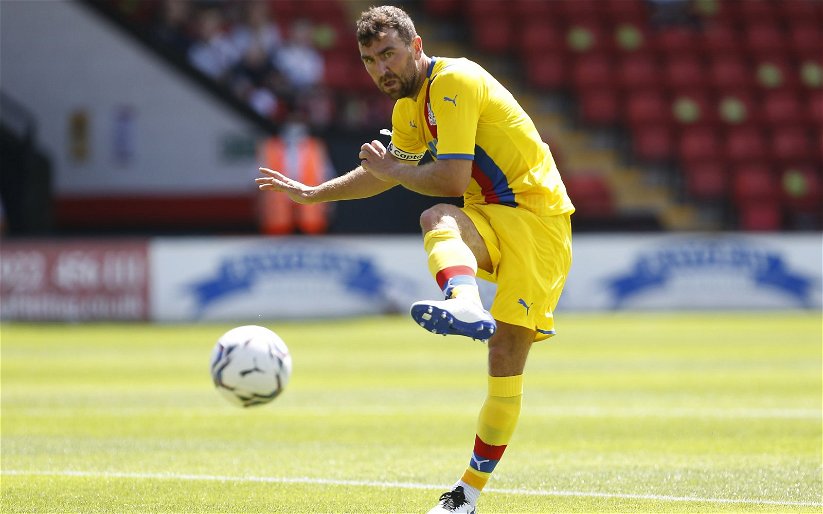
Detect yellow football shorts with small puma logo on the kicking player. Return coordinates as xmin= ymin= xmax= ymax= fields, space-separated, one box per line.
xmin=463 ymin=204 xmax=572 ymax=341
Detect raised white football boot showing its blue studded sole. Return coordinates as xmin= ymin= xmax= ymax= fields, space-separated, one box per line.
xmin=411 ymin=297 xmax=497 ymax=341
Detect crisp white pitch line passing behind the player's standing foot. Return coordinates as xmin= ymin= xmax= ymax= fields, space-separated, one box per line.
xmin=0 ymin=469 xmax=823 ymax=507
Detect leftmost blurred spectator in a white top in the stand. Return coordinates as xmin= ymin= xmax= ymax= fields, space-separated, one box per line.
xmin=188 ymin=7 xmax=241 ymax=81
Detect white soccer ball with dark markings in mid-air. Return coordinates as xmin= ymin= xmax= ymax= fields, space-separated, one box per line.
xmin=211 ymin=325 xmax=291 ymax=407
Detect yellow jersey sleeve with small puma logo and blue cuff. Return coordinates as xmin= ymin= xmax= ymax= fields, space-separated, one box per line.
xmin=429 ymin=69 xmax=485 ymax=160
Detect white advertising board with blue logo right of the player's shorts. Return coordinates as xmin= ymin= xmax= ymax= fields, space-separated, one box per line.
xmin=559 ymin=233 xmax=823 ymax=310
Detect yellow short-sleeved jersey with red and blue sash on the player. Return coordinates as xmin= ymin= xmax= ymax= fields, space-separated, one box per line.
xmin=388 ymin=57 xmax=574 ymax=216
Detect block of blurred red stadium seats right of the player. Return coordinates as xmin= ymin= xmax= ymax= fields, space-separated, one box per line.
xmin=423 ymin=0 xmax=823 ymax=231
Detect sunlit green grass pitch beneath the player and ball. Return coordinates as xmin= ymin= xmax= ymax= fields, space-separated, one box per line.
xmin=0 ymin=313 xmax=823 ymax=513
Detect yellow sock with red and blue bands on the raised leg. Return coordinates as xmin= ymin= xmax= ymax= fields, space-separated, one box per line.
xmin=423 ymin=228 xmax=480 ymax=302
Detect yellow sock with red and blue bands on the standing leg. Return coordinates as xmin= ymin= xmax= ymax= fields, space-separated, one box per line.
xmin=461 ymin=375 xmax=523 ymax=491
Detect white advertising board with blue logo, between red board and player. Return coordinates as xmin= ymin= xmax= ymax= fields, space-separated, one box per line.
xmin=151 ymin=236 xmax=442 ymax=322
